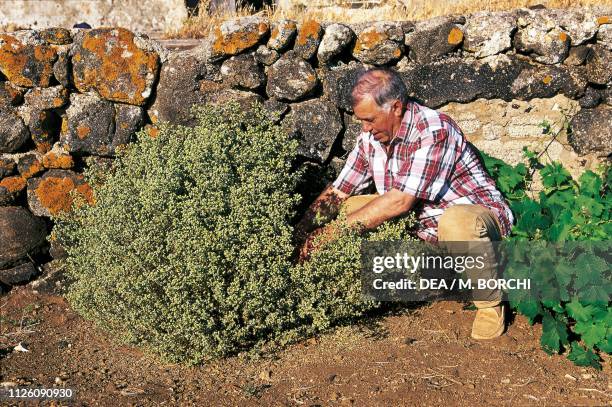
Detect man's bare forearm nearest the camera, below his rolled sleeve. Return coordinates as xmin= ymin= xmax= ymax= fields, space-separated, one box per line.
xmin=347 ymin=189 xmax=417 ymax=229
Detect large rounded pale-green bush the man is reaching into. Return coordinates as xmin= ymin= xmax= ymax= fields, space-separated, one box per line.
xmin=54 ymin=105 xmax=418 ymax=363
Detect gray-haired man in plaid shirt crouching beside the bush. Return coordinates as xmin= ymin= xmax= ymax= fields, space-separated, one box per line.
xmin=297 ymin=68 xmax=513 ymax=339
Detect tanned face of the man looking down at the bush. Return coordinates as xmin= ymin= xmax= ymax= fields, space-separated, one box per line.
xmin=353 ymin=95 xmax=402 ymax=144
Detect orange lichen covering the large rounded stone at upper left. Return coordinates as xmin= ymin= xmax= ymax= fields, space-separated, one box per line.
xmin=73 ymin=28 xmax=159 ymax=105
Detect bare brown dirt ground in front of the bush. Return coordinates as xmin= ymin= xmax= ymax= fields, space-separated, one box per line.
xmin=0 ymin=287 xmax=612 ymax=406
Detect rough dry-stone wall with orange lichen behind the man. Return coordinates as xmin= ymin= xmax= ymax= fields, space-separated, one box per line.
xmin=0 ymin=8 xmax=612 ymax=292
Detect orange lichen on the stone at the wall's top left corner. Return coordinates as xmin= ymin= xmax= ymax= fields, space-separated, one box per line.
xmin=0 ymin=34 xmax=57 ymax=88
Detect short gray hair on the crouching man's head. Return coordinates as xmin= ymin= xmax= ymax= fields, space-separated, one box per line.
xmin=351 ymin=68 xmax=410 ymax=106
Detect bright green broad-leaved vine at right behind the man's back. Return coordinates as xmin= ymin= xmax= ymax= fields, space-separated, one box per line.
xmin=484 ymin=150 xmax=612 ymax=368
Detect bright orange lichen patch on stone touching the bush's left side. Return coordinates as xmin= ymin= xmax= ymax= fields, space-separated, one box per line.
xmin=35 ymin=177 xmax=94 ymax=215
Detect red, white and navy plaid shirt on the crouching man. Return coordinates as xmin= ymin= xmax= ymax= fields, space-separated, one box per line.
xmin=333 ymin=102 xmax=513 ymax=242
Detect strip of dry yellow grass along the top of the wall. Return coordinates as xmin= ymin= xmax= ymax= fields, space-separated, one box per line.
xmin=166 ymin=0 xmax=612 ymax=38
